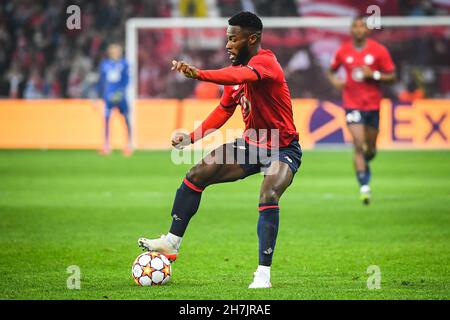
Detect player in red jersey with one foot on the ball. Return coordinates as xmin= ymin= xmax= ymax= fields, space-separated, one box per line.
xmin=138 ymin=12 xmax=302 ymax=288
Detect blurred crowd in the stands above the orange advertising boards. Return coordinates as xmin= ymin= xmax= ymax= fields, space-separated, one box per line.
xmin=0 ymin=0 xmax=450 ymax=101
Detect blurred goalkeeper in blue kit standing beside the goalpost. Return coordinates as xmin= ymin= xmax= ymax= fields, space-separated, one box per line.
xmin=98 ymin=43 xmax=133 ymax=156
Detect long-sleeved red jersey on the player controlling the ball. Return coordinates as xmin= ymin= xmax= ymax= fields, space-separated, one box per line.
xmin=191 ymin=49 xmax=298 ymax=148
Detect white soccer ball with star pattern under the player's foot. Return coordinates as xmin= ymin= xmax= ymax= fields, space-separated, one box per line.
xmin=131 ymin=251 xmax=172 ymax=286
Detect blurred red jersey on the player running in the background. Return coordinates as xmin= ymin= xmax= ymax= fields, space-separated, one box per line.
xmin=331 ymin=39 xmax=395 ymax=111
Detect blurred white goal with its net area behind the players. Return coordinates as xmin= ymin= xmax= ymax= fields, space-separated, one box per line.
xmin=126 ymin=16 xmax=450 ymax=151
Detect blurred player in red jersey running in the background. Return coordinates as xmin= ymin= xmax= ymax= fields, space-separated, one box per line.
xmin=328 ymin=17 xmax=395 ymax=205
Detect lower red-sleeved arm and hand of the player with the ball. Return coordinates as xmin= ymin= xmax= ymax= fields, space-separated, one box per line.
xmin=172 ymin=104 xmax=236 ymax=149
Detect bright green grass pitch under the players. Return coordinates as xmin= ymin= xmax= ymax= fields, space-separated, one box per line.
xmin=0 ymin=150 xmax=450 ymax=300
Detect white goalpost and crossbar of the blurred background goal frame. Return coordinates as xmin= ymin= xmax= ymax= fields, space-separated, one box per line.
xmin=125 ymin=16 xmax=450 ymax=145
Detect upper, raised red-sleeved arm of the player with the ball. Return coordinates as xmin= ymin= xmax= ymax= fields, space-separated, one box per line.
xmin=172 ymin=60 xmax=261 ymax=85
